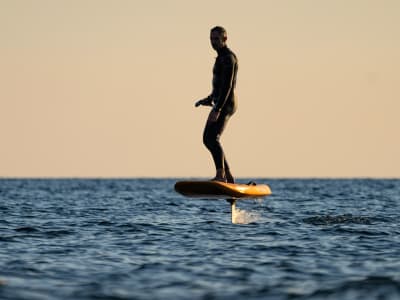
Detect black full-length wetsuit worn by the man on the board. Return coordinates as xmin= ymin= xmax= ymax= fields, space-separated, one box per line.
xmin=203 ymin=47 xmax=238 ymax=169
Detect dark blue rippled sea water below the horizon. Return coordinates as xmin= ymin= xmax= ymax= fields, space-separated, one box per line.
xmin=0 ymin=179 xmax=400 ymax=300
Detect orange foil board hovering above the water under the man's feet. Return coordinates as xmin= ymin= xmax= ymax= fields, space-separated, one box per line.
xmin=175 ymin=180 xmax=271 ymax=199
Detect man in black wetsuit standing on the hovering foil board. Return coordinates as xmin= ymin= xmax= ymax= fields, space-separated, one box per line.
xmin=195 ymin=26 xmax=238 ymax=183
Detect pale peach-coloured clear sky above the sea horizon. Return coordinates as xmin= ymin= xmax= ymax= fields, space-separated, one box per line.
xmin=0 ymin=0 xmax=400 ymax=178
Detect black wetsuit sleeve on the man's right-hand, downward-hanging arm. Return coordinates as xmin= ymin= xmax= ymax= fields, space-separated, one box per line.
xmin=214 ymin=55 xmax=236 ymax=111
